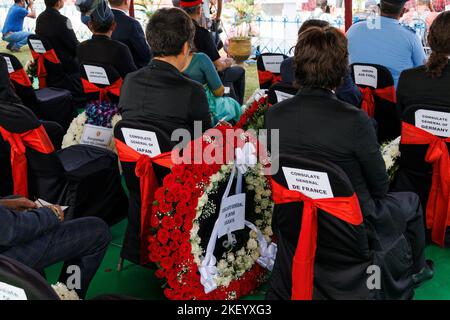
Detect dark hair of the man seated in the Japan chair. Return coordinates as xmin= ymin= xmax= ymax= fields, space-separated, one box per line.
xmin=146 ymin=8 xmax=195 ymax=57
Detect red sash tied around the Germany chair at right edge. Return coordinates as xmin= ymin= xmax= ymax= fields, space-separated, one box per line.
xmin=400 ymin=122 xmax=450 ymax=247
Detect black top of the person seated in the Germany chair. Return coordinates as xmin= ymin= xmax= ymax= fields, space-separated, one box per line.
xmin=397 ymin=63 xmax=450 ymax=114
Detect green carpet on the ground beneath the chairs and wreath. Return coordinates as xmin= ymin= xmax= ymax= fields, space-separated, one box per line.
xmin=46 ymin=220 xmax=450 ymax=300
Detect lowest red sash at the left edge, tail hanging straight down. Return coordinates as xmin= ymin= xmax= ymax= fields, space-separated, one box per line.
xmin=0 ymin=125 xmax=55 ymax=197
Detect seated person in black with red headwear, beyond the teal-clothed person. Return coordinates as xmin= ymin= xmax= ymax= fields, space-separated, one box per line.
xmin=180 ymin=0 xmax=245 ymax=104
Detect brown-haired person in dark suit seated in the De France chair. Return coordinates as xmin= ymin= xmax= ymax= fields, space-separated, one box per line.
xmin=265 ymin=27 xmax=433 ymax=298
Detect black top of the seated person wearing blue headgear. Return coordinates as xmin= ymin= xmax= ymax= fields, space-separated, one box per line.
xmin=77 ymin=35 xmax=136 ymax=79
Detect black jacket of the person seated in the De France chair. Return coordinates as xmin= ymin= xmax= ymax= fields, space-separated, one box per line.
xmin=265 ymin=88 xmax=389 ymax=215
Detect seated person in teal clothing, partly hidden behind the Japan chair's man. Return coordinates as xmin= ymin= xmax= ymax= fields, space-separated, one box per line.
xmin=183 ymin=52 xmax=242 ymax=125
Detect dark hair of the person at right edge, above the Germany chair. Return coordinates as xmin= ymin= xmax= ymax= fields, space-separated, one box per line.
xmin=426 ymin=11 xmax=450 ymax=78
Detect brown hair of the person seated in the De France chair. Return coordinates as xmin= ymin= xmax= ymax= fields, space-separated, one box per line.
xmin=294 ymin=27 xmax=348 ymax=89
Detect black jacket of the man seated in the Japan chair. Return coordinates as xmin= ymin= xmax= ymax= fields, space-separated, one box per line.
xmin=119 ymin=59 xmax=211 ymax=137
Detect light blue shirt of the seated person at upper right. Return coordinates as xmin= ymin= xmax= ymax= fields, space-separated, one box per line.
xmin=347 ymin=17 xmax=426 ymax=87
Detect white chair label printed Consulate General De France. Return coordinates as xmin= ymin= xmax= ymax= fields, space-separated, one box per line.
xmin=283 ymin=167 xmax=333 ymax=199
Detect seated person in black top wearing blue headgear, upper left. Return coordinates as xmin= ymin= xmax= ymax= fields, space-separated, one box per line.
xmin=77 ymin=0 xmax=137 ymax=79
